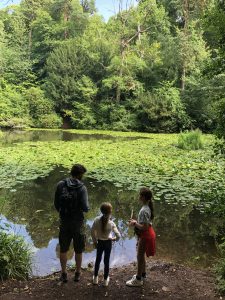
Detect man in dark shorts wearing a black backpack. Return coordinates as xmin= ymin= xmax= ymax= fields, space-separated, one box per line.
xmin=54 ymin=164 xmax=89 ymax=283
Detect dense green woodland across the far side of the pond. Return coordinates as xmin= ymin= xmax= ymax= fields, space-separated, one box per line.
xmin=0 ymin=0 xmax=225 ymax=134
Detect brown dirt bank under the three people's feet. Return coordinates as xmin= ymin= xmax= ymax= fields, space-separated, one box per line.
xmin=0 ymin=261 xmax=223 ymax=300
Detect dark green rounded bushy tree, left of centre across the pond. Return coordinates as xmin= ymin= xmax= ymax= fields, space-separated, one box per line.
xmin=47 ymin=41 xmax=96 ymax=111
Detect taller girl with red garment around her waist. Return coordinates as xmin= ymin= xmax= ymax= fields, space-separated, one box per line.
xmin=126 ymin=187 xmax=156 ymax=287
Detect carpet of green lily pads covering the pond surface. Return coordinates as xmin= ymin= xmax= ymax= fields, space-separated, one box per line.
xmin=0 ymin=131 xmax=222 ymax=212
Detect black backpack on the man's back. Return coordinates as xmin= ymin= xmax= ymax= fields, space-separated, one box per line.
xmin=59 ymin=180 xmax=80 ymax=218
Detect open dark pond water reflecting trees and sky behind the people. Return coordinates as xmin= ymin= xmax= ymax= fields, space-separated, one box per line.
xmin=0 ymin=168 xmax=217 ymax=275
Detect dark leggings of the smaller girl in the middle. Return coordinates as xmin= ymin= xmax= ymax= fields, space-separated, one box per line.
xmin=95 ymin=240 xmax=112 ymax=279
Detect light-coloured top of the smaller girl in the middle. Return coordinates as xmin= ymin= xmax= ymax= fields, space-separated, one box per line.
xmin=91 ymin=216 xmax=121 ymax=243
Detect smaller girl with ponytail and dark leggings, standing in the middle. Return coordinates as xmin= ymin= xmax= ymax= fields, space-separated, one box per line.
xmin=91 ymin=203 xmax=120 ymax=286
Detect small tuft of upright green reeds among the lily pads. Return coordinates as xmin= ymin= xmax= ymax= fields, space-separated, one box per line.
xmin=178 ymin=129 xmax=203 ymax=150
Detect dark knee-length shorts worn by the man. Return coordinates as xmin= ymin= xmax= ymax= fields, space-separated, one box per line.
xmin=59 ymin=221 xmax=86 ymax=254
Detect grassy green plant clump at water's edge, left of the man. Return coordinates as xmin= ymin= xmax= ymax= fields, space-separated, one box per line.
xmin=0 ymin=231 xmax=31 ymax=280
